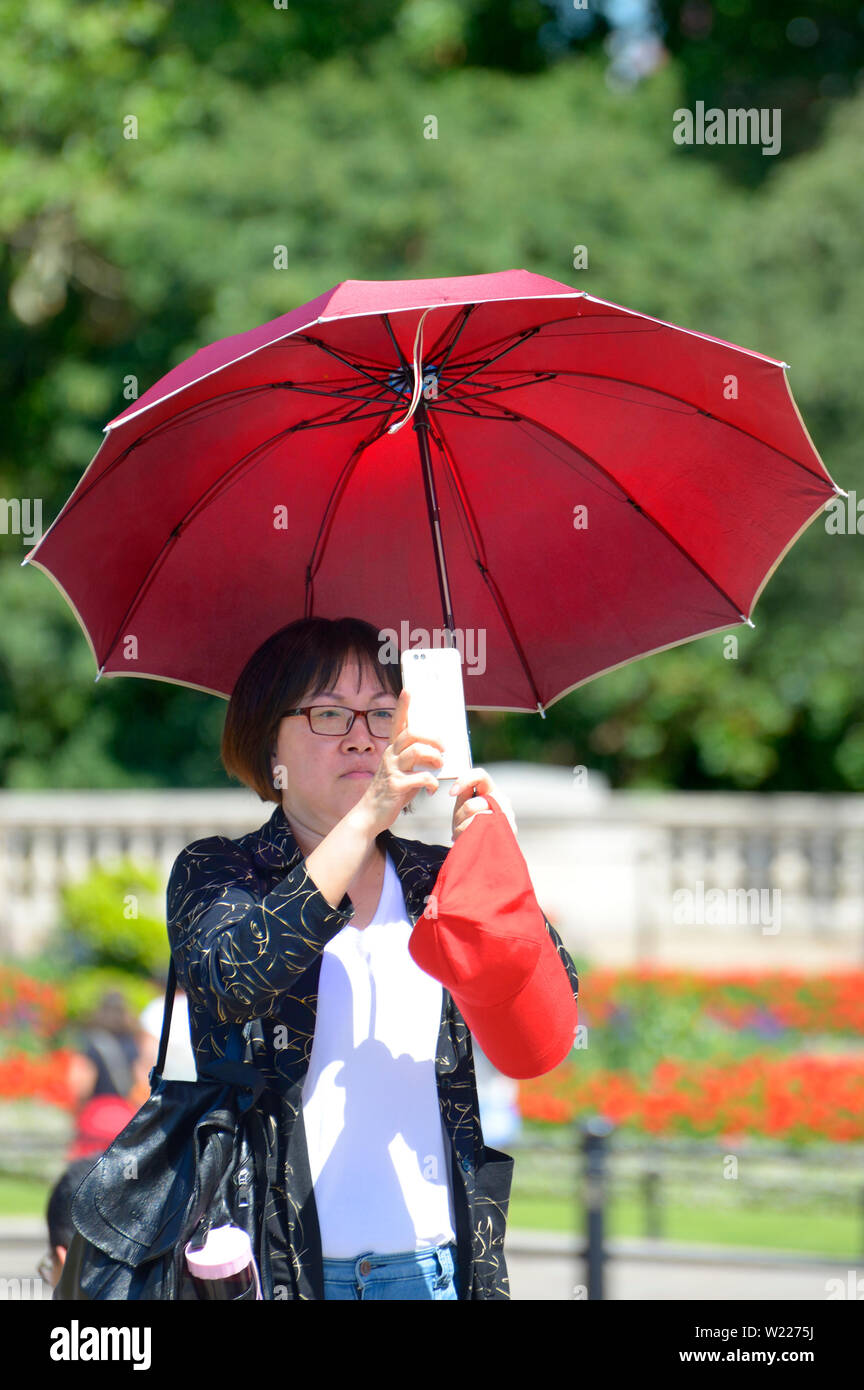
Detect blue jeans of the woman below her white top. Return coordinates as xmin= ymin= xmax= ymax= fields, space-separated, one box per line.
xmin=324 ymin=1245 xmax=460 ymax=1302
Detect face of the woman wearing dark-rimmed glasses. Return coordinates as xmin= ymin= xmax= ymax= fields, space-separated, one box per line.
xmin=271 ymin=656 xmax=397 ymax=849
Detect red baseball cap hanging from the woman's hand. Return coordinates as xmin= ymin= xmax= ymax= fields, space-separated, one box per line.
xmin=408 ymin=792 xmax=576 ymax=1079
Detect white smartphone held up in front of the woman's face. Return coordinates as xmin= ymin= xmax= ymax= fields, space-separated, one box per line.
xmin=400 ymin=646 xmax=474 ymax=781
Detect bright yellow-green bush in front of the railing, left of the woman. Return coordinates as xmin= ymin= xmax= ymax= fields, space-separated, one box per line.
xmin=60 ymin=860 xmax=168 ymax=992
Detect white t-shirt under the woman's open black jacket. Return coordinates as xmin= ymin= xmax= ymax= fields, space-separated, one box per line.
xmin=303 ymin=856 xmax=456 ymax=1258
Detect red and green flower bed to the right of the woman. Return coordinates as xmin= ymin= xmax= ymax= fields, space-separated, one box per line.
xmin=520 ymin=966 xmax=864 ymax=1143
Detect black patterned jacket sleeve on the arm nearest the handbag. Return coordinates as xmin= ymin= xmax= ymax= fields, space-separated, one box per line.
xmin=167 ymin=835 xmax=354 ymax=1023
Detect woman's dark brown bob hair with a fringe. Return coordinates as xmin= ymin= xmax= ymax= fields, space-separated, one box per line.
xmin=221 ymin=617 xmax=407 ymax=809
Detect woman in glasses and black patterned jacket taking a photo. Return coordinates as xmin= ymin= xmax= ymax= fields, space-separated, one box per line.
xmin=168 ymin=619 xmax=578 ymax=1300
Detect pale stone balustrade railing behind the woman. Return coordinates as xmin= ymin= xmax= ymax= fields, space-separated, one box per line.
xmin=0 ymin=763 xmax=864 ymax=969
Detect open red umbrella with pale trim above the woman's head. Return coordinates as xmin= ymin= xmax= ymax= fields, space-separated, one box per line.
xmin=25 ymin=270 xmax=842 ymax=710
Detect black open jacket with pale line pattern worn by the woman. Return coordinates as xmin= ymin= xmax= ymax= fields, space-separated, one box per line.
xmin=167 ymin=806 xmax=579 ymax=1300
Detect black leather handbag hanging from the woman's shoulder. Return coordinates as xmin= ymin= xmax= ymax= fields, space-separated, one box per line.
xmin=54 ymin=960 xmax=274 ymax=1300
